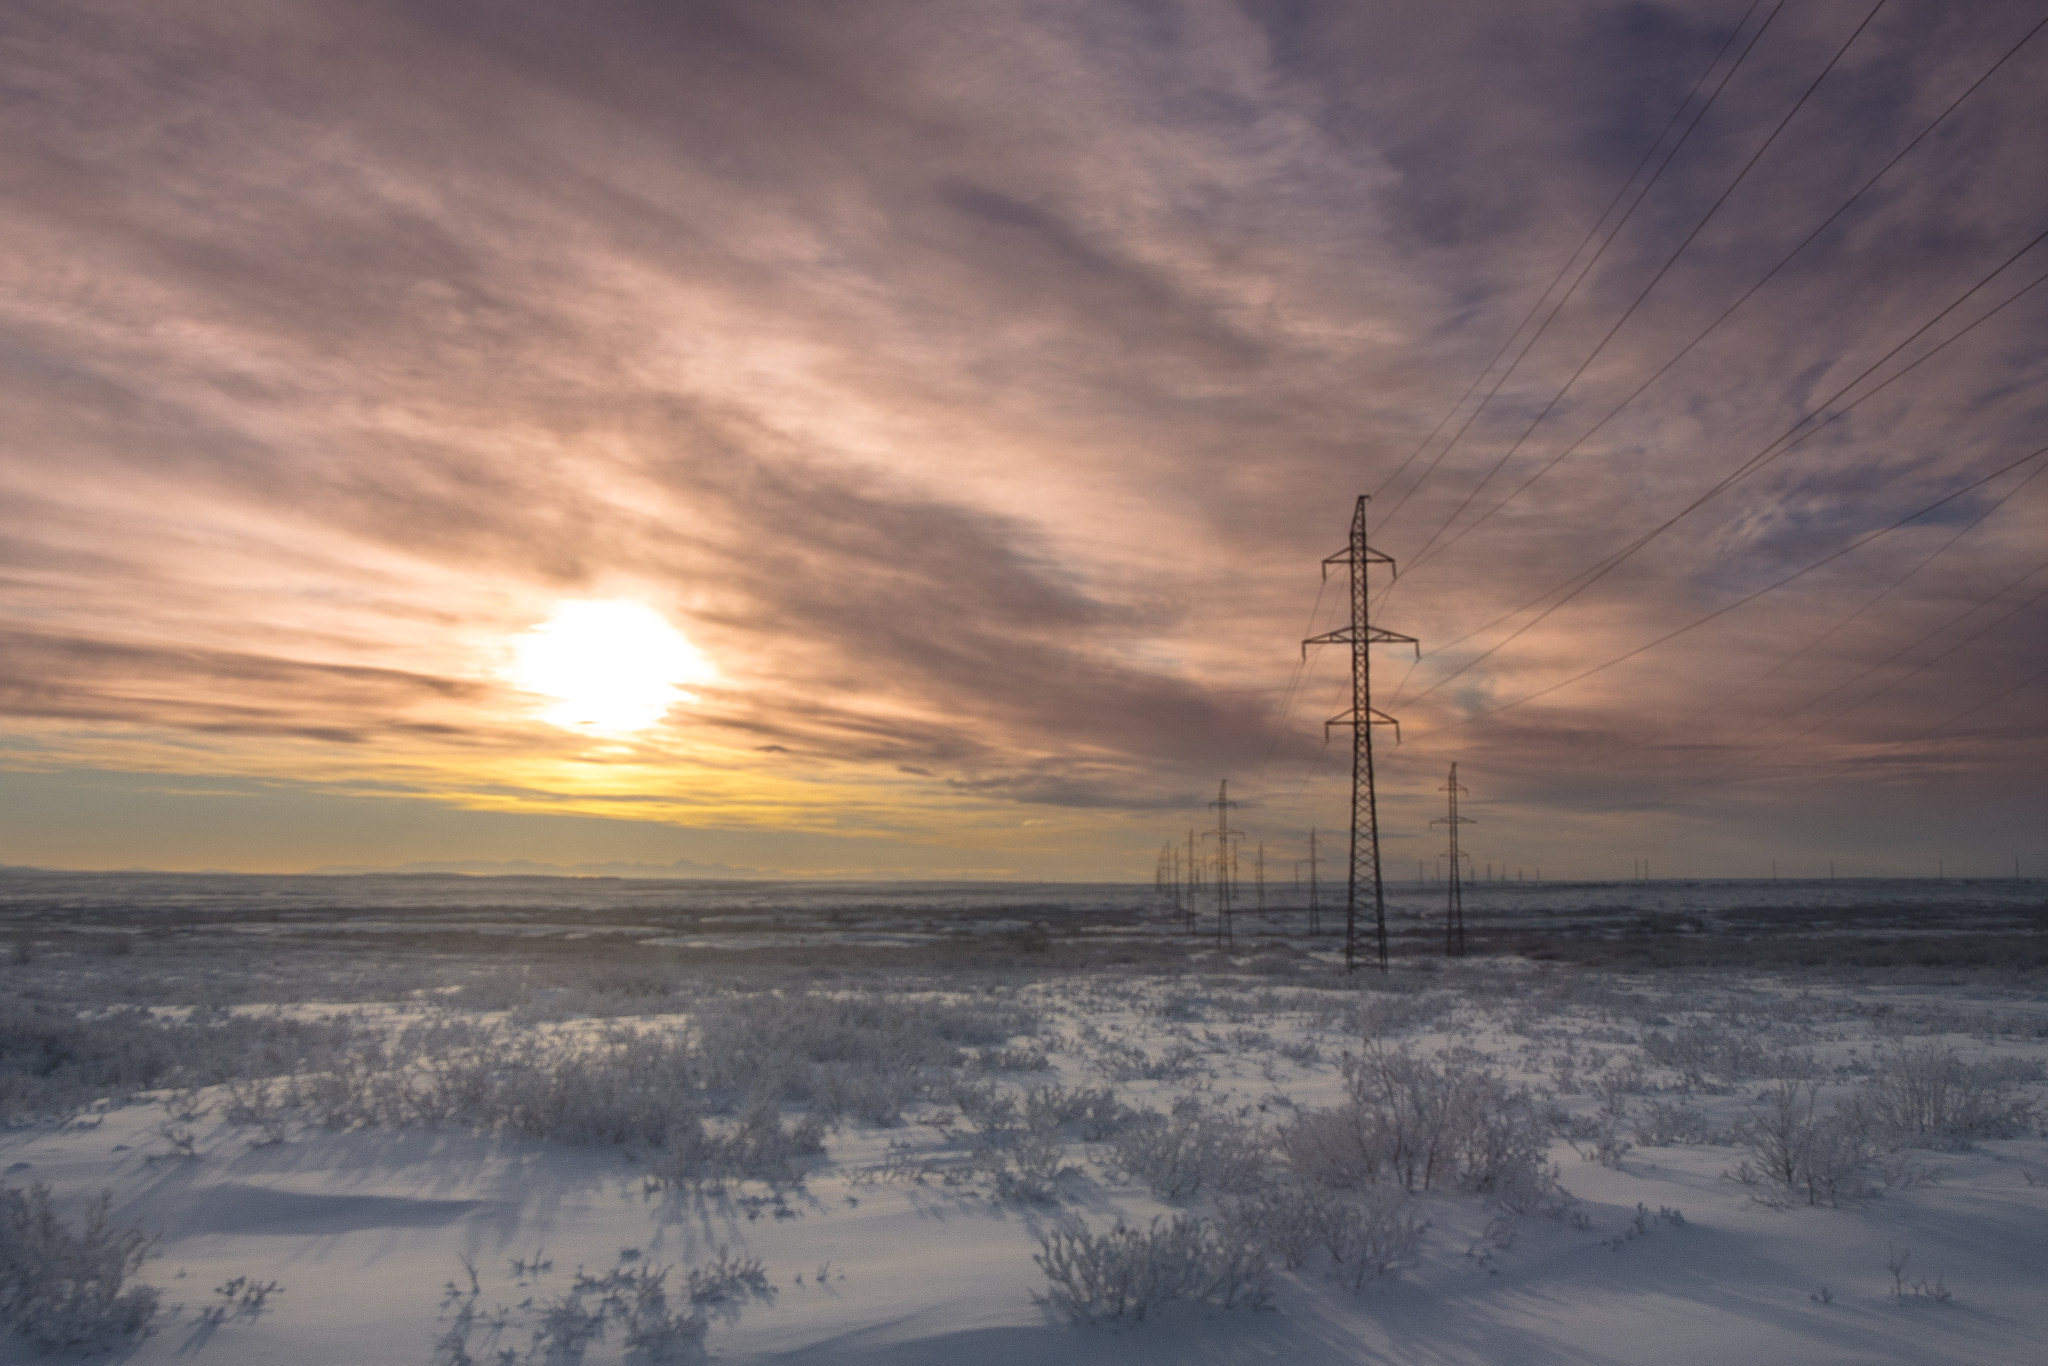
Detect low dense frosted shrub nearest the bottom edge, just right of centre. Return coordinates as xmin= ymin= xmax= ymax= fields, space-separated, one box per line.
xmin=1032 ymin=1214 xmax=1272 ymax=1323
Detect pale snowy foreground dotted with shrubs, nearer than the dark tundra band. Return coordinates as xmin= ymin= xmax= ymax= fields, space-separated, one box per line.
xmin=0 ymin=958 xmax=2048 ymax=1366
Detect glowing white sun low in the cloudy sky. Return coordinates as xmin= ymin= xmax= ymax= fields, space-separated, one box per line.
xmin=508 ymin=602 xmax=717 ymax=735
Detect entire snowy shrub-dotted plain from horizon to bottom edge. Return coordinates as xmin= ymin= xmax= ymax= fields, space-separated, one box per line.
xmin=0 ymin=872 xmax=2048 ymax=1366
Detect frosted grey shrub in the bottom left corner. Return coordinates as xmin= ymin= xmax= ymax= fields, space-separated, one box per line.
xmin=0 ymin=1184 xmax=158 ymax=1350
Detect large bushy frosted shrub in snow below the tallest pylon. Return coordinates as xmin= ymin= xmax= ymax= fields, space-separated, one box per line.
xmin=1278 ymin=1051 xmax=1554 ymax=1208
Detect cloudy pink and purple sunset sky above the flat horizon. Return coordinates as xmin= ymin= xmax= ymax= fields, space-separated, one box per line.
xmin=0 ymin=0 xmax=2048 ymax=881
